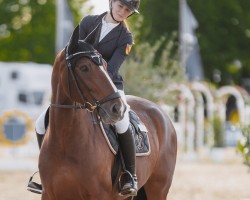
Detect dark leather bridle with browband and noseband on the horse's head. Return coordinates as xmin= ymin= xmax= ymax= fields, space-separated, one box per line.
xmin=50 ymin=46 xmax=121 ymax=112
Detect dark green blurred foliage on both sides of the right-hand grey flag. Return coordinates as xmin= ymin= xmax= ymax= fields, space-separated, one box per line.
xmin=130 ymin=0 xmax=250 ymax=85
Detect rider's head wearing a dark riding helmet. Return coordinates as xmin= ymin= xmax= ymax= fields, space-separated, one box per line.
xmin=109 ymin=0 xmax=140 ymax=22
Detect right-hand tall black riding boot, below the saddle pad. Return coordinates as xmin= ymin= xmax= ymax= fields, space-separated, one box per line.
xmin=118 ymin=126 xmax=138 ymax=196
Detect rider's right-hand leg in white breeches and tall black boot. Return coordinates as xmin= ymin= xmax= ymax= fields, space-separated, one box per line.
xmin=115 ymin=91 xmax=138 ymax=196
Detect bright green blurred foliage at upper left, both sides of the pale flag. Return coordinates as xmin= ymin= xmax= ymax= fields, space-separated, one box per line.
xmin=0 ymin=0 xmax=88 ymax=64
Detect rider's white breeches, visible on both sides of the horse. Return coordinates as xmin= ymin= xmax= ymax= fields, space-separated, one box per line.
xmin=35 ymin=90 xmax=130 ymax=135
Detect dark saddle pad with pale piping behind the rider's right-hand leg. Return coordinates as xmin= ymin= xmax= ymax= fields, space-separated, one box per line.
xmin=100 ymin=110 xmax=150 ymax=156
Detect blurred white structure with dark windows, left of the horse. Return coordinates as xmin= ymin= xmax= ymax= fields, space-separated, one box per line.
xmin=0 ymin=62 xmax=52 ymax=118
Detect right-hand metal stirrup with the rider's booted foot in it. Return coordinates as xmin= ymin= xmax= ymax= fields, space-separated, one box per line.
xmin=118 ymin=170 xmax=138 ymax=196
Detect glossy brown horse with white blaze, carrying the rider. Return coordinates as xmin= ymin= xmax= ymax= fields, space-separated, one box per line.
xmin=39 ymin=27 xmax=177 ymax=200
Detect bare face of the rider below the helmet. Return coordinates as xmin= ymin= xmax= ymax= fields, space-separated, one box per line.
xmin=112 ymin=0 xmax=133 ymax=22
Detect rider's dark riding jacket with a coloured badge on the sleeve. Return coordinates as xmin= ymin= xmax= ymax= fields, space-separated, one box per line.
xmin=79 ymin=12 xmax=133 ymax=90
